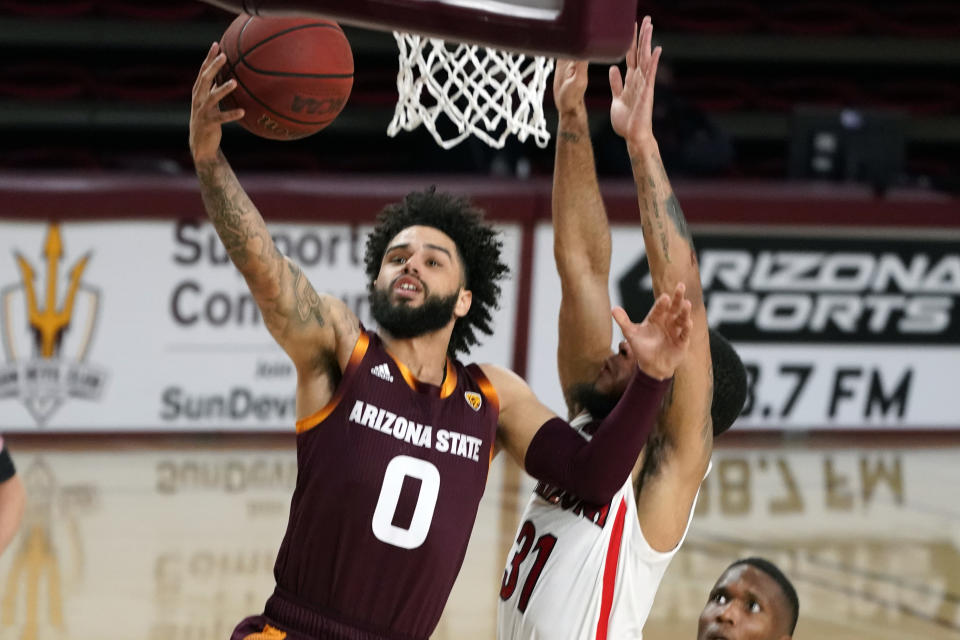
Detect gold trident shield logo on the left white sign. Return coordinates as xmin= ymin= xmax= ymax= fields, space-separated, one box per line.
xmin=0 ymin=224 xmax=106 ymax=426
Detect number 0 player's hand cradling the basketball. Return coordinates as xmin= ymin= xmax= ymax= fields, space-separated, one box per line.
xmin=190 ymin=42 xmax=243 ymax=163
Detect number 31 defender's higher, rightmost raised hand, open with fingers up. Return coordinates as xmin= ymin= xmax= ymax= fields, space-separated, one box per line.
xmin=610 ymin=16 xmax=663 ymax=145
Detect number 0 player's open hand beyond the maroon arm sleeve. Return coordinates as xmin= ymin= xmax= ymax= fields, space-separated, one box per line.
xmin=613 ymin=282 xmax=693 ymax=380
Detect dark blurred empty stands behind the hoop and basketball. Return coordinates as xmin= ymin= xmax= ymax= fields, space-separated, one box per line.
xmin=0 ymin=0 xmax=960 ymax=193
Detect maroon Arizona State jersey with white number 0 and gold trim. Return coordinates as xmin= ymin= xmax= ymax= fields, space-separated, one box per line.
xmin=267 ymin=331 xmax=499 ymax=639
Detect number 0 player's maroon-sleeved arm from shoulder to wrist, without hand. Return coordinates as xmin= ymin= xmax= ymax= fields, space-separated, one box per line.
xmin=483 ymin=365 xmax=668 ymax=504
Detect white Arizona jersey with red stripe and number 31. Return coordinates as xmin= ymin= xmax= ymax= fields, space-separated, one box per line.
xmin=497 ymin=413 xmax=696 ymax=640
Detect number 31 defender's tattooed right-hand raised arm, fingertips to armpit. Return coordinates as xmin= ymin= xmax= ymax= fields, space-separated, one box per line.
xmin=610 ymin=17 xmax=713 ymax=551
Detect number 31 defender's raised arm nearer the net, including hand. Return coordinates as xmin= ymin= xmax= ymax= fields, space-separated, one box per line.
xmin=552 ymin=59 xmax=613 ymax=411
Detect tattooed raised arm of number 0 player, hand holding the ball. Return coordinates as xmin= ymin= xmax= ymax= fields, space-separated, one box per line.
xmin=190 ymin=43 xmax=359 ymax=378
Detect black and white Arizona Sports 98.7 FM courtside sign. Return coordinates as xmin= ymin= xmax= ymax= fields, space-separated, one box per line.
xmin=530 ymin=224 xmax=960 ymax=429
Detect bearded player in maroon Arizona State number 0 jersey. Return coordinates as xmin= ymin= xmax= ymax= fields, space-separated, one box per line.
xmin=190 ymin=44 xmax=691 ymax=640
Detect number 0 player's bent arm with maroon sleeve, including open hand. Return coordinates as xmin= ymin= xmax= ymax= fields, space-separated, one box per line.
xmin=483 ymin=285 xmax=691 ymax=504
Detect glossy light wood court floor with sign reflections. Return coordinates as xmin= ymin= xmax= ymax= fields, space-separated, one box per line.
xmin=0 ymin=435 xmax=960 ymax=640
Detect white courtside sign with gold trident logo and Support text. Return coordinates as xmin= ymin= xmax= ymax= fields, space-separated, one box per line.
xmin=0 ymin=221 xmax=520 ymax=432
